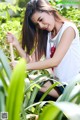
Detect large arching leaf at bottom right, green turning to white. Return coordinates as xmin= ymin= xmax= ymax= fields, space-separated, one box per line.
xmin=39 ymin=102 xmax=80 ymax=120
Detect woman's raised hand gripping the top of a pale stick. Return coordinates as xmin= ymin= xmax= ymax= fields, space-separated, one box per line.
xmin=6 ymin=32 xmax=19 ymax=47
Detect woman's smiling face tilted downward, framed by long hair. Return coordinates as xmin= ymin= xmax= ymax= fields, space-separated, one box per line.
xmin=31 ymin=11 xmax=55 ymax=32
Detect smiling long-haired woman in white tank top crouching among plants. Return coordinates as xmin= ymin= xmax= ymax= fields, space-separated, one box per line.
xmin=7 ymin=0 xmax=80 ymax=97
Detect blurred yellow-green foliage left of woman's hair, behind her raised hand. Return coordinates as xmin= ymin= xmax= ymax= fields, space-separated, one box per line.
xmin=0 ymin=2 xmax=24 ymax=59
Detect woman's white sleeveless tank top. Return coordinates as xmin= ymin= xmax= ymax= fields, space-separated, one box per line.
xmin=46 ymin=22 xmax=80 ymax=83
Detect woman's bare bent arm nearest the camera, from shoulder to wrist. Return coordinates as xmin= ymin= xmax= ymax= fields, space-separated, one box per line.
xmin=27 ymin=27 xmax=75 ymax=70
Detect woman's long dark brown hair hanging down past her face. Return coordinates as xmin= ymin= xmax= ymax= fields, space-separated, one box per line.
xmin=22 ymin=0 xmax=64 ymax=59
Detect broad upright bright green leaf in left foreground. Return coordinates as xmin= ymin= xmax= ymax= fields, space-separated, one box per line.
xmin=6 ymin=59 xmax=26 ymax=120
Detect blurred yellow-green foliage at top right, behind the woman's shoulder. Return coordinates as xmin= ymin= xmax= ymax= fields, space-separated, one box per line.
xmin=49 ymin=0 xmax=80 ymax=32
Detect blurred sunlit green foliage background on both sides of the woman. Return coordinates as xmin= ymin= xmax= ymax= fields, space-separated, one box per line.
xmin=0 ymin=0 xmax=80 ymax=59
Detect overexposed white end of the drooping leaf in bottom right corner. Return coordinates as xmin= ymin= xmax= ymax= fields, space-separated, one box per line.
xmin=53 ymin=102 xmax=80 ymax=120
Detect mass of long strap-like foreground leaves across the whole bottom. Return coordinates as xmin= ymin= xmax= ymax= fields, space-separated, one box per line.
xmin=0 ymin=50 xmax=80 ymax=120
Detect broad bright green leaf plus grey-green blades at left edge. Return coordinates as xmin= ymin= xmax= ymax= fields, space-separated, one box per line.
xmin=0 ymin=51 xmax=26 ymax=120
